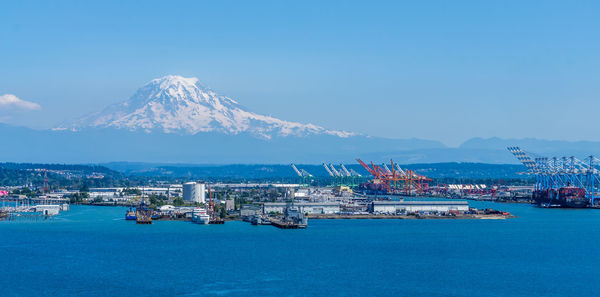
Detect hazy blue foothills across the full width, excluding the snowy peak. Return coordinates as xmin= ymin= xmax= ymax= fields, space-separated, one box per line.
xmin=0 ymin=124 xmax=600 ymax=164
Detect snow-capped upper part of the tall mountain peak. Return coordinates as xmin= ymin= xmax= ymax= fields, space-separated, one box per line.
xmin=64 ymin=75 xmax=354 ymax=139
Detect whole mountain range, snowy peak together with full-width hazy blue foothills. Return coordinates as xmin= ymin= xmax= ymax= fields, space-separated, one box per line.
xmin=0 ymin=75 xmax=600 ymax=164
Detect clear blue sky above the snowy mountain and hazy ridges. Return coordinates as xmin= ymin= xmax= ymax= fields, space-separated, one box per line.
xmin=0 ymin=1 xmax=600 ymax=145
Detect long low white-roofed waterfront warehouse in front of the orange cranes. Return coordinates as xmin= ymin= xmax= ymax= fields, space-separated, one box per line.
xmin=369 ymin=201 xmax=469 ymax=214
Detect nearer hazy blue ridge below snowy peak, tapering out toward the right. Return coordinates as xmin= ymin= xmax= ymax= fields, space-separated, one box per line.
xmin=0 ymin=124 xmax=444 ymax=164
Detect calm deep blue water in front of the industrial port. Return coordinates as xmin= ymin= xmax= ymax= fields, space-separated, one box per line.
xmin=0 ymin=202 xmax=600 ymax=296
